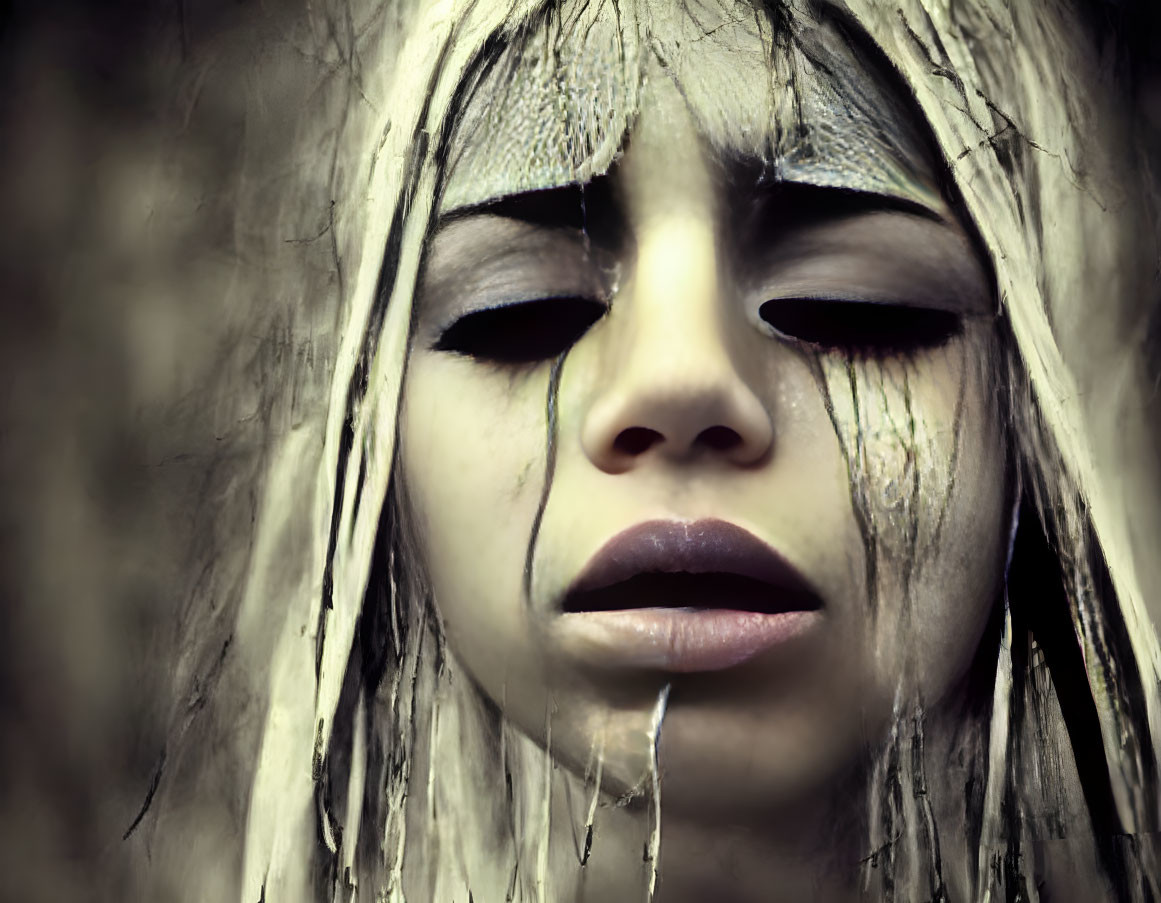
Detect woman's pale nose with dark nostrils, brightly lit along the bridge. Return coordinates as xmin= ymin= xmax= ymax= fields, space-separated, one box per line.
xmin=581 ymin=216 xmax=773 ymax=474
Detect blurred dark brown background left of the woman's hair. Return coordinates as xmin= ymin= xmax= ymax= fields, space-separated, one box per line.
xmin=0 ymin=0 xmax=352 ymax=903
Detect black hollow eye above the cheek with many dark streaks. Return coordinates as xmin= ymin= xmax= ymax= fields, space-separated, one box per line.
xmin=758 ymin=298 xmax=962 ymax=356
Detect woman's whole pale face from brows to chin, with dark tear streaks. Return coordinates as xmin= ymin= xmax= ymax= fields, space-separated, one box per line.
xmin=401 ymin=12 xmax=1005 ymax=811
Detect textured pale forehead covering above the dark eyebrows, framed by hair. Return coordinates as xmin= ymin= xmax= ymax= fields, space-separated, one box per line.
xmin=441 ymin=0 xmax=945 ymax=212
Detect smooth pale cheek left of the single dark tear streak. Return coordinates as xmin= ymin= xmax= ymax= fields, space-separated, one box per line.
xmin=399 ymin=352 xmax=547 ymax=677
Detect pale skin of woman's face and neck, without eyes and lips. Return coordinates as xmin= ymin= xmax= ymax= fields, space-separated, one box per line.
xmin=401 ymin=58 xmax=1011 ymax=902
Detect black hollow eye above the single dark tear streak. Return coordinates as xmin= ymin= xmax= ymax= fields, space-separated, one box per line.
xmin=433 ymin=297 xmax=607 ymax=366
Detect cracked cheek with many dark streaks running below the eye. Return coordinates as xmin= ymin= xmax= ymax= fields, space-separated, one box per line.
xmin=823 ymin=339 xmax=1007 ymax=701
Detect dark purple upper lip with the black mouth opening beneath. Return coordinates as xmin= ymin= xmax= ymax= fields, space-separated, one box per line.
xmin=563 ymin=520 xmax=822 ymax=613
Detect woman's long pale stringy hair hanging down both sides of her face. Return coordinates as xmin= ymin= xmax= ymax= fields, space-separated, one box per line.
xmin=224 ymin=0 xmax=1161 ymax=902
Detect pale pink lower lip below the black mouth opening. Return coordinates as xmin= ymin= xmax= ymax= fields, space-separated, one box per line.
xmin=557 ymin=608 xmax=822 ymax=673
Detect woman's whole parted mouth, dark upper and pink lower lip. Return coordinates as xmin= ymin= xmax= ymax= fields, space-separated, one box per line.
xmin=554 ymin=520 xmax=822 ymax=673
